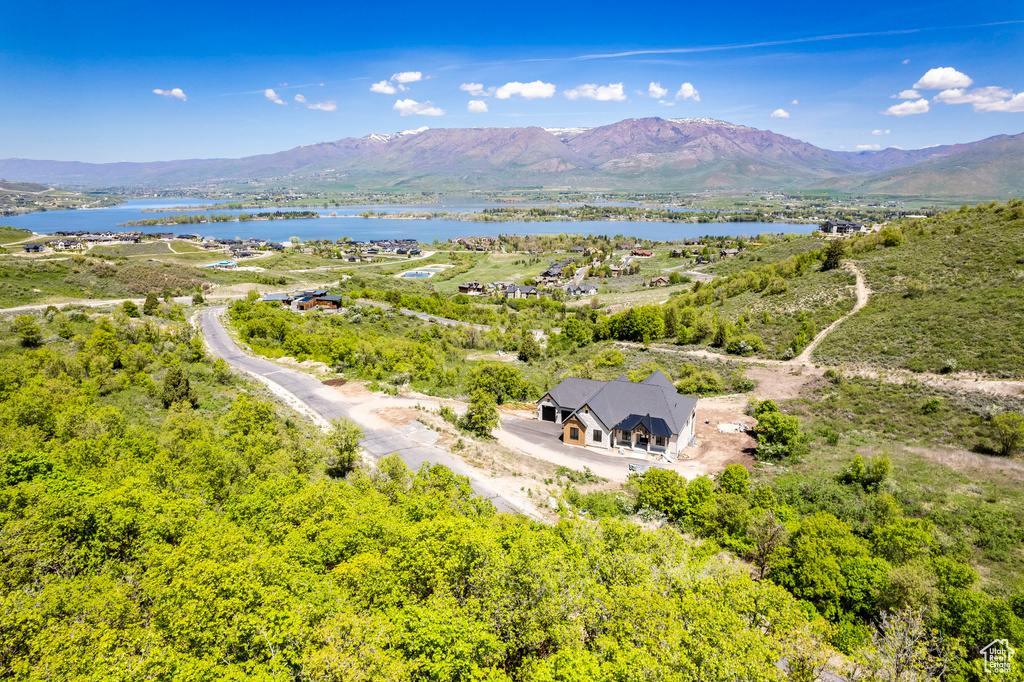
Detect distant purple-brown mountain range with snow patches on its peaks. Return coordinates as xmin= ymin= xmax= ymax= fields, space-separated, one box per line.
xmin=0 ymin=118 xmax=1024 ymax=198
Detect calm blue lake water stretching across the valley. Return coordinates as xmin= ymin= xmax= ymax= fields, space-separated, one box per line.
xmin=0 ymin=199 xmax=817 ymax=244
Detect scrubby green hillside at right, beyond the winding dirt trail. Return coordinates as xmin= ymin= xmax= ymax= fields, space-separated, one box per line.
xmin=815 ymin=202 xmax=1024 ymax=377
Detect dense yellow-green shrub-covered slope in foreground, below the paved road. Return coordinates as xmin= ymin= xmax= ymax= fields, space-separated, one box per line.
xmin=0 ymin=311 xmax=830 ymax=682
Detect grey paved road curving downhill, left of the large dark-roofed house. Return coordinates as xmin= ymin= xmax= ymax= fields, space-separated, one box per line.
xmin=199 ymin=306 xmax=528 ymax=515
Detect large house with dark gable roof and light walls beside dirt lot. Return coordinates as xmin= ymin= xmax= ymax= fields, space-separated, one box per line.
xmin=537 ymin=371 xmax=697 ymax=455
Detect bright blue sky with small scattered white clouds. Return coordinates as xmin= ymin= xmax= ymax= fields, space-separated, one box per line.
xmin=0 ymin=0 xmax=1024 ymax=162
